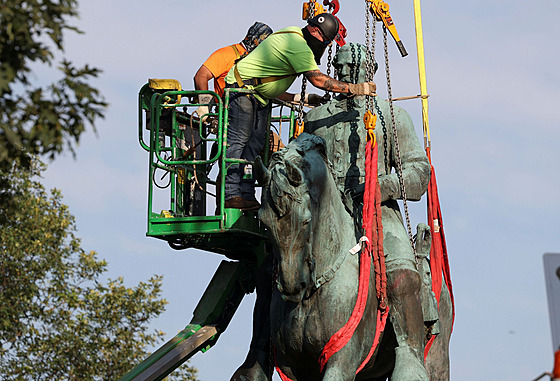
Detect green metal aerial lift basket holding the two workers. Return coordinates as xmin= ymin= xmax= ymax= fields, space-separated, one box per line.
xmin=138 ymin=79 xmax=295 ymax=259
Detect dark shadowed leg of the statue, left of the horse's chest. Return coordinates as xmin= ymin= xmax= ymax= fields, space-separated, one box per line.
xmin=230 ymin=253 xmax=273 ymax=381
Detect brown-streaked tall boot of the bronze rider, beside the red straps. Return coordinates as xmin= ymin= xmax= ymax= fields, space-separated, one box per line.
xmin=387 ymin=269 xmax=429 ymax=381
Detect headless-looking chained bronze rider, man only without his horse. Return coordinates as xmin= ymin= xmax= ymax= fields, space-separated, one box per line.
xmin=305 ymin=43 xmax=430 ymax=381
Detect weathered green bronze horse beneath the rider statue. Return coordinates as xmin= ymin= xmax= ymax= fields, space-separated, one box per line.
xmin=254 ymin=133 xmax=451 ymax=381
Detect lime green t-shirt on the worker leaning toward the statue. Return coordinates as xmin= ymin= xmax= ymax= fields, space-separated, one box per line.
xmin=226 ymin=26 xmax=319 ymax=103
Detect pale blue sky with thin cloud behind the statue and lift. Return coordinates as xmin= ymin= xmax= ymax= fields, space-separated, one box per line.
xmin=40 ymin=0 xmax=560 ymax=381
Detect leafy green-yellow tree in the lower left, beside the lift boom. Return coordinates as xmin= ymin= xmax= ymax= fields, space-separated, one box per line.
xmin=0 ymin=160 xmax=196 ymax=381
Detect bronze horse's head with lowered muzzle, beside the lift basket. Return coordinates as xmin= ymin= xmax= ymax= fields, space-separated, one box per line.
xmin=255 ymin=134 xmax=339 ymax=303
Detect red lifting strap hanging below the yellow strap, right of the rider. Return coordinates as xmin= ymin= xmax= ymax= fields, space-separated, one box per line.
xmin=424 ymin=147 xmax=455 ymax=359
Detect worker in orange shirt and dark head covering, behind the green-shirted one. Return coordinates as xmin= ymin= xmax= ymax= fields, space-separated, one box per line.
xmin=194 ymin=21 xmax=272 ymax=121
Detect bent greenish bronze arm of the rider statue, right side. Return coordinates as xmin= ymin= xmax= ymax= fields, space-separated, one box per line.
xmin=379 ymin=107 xmax=430 ymax=201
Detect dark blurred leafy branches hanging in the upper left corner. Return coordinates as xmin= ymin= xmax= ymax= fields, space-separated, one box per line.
xmin=0 ymin=0 xmax=107 ymax=169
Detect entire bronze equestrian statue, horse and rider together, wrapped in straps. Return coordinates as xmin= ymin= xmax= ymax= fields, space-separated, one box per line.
xmin=232 ymin=44 xmax=451 ymax=381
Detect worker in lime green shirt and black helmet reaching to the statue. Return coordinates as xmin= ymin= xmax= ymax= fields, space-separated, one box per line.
xmin=225 ymin=13 xmax=375 ymax=210
